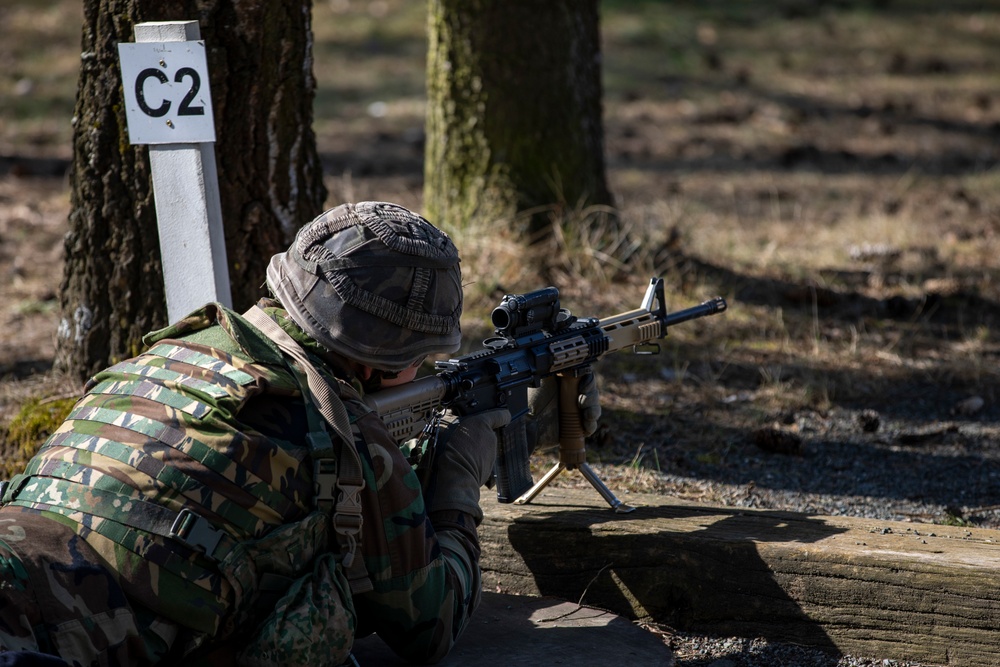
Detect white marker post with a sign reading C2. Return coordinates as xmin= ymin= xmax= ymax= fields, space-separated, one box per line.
xmin=118 ymin=21 xmax=232 ymax=322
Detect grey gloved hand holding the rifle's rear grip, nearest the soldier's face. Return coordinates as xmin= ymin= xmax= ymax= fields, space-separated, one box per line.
xmin=417 ymin=409 xmax=510 ymax=525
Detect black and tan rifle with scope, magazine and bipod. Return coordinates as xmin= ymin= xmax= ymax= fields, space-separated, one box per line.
xmin=365 ymin=278 xmax=726 ymax=512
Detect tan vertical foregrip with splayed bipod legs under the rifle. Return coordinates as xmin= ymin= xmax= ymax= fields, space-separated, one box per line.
xmin=514 ymin=375 xmax=635 ymax=514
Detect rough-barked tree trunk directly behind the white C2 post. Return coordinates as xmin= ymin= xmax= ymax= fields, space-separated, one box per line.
xmin=56 ymin=0 xmax=326 ymax=378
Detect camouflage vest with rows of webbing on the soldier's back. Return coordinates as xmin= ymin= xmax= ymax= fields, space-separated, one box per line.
xmin=3 ymin=304 xmax=366 ymax=664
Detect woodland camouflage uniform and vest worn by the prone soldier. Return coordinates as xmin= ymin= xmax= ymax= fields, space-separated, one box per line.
xmin=0 ymin=204 xmax=481 ymax=665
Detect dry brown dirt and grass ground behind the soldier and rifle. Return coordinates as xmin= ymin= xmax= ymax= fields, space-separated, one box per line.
xmin=0 ymin=0 xmax=1000 ymax=664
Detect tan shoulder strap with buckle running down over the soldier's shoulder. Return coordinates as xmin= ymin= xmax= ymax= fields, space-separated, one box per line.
xmin=243 ymin=306 xmax=372 ymax=593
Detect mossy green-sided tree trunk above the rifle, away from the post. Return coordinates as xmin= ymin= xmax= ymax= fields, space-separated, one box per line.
xmin=424 ymin=0 xmax=611 ymax=239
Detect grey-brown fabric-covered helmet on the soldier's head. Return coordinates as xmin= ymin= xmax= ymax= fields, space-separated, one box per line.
xmin=267 ymin=202 xmax=462 ymax=371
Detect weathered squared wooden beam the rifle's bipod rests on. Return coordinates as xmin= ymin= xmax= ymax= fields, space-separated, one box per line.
xmin=480 ymin=488 xmax=1000 ymax=666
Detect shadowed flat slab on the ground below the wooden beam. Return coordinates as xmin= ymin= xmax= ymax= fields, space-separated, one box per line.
xmin=354 ymin=593 xmax=674 ymax=667
